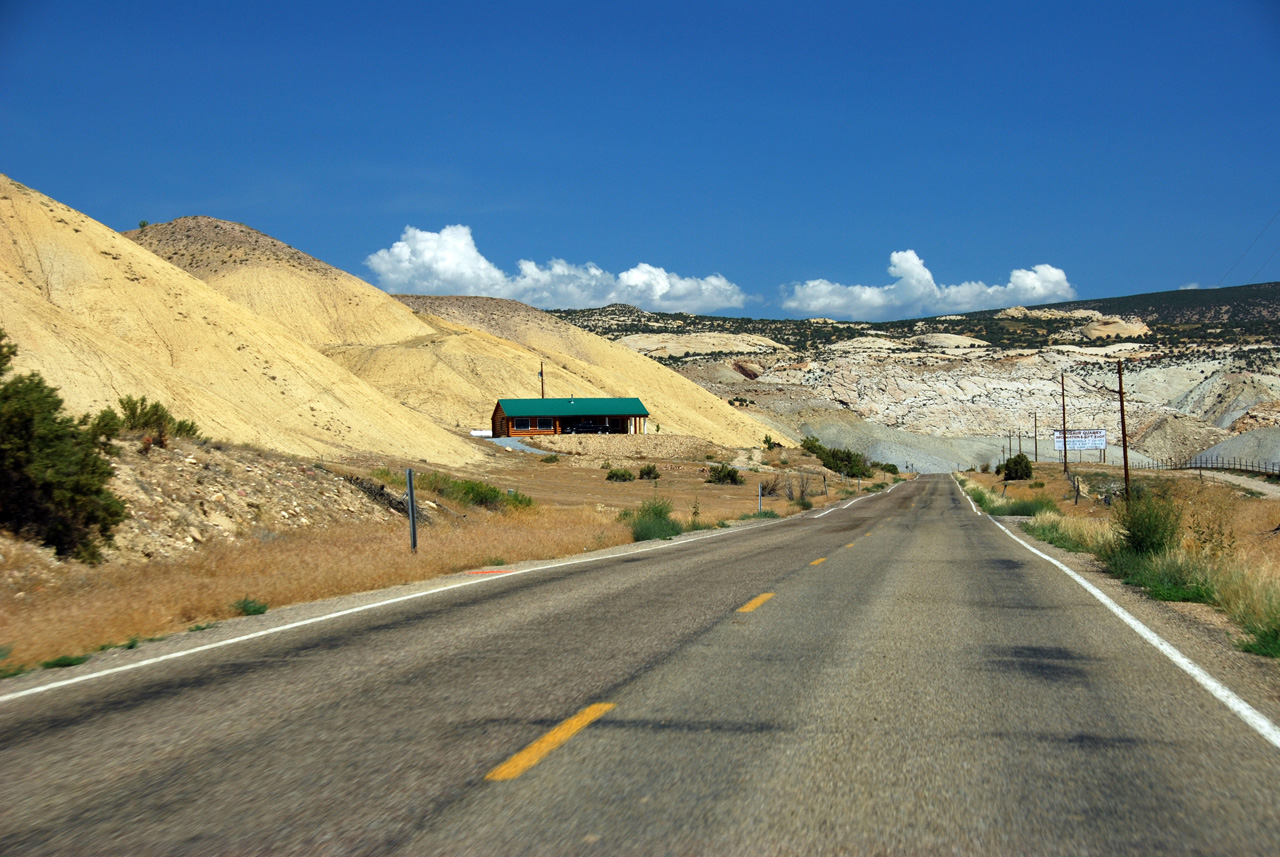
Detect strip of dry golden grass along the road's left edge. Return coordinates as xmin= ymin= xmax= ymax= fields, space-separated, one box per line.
xmin=0 ymin=507 xmax=631 ymax=668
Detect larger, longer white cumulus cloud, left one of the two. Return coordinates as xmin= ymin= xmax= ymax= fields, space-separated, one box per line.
xmin=365 ymin=225 xmax=746 ymax=312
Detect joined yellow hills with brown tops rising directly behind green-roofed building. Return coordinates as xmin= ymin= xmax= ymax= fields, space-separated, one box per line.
xmin=125 ymin=211 xmax=769 ymax=446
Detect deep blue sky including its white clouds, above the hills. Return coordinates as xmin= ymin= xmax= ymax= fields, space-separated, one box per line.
xmin=0 ymin=0 xmax=1280 ymax=320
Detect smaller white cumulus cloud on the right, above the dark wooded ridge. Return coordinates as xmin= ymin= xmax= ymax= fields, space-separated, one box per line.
xmin=782 ymin=249 xmax=1075 ymax=321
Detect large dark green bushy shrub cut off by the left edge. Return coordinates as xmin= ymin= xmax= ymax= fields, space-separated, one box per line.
xmin=0 ymin=330 xmax=125 ymax=563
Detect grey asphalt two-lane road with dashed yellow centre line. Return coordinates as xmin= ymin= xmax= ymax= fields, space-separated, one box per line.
xmin=0 ymin=477 xmax=1280 ymax=854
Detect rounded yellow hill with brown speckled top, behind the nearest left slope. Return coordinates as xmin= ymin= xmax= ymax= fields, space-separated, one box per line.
xmin=123 ymin=216 xmax=433 ymax=347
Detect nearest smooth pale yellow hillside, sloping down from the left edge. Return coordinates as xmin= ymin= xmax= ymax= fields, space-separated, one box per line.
xmin=0 ymin=177 xmax=479 ymax=462
